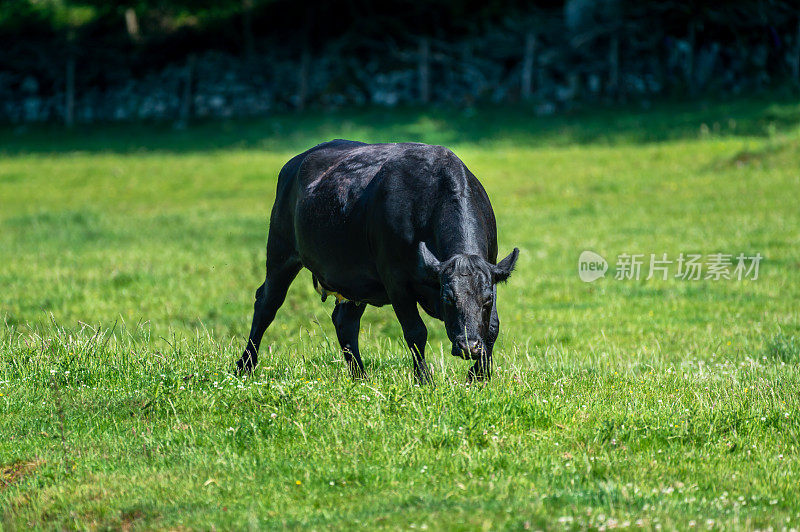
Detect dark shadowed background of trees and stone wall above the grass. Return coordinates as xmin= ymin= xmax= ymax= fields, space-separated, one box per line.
xmin=0 ymin=0 xmax=800 ymax=124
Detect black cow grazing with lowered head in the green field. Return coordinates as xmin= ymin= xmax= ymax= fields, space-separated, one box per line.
xmin=237 ymin=140 xmax=519 ymax=382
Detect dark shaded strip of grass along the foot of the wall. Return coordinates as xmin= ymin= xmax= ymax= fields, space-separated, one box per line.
xmin=0 ymin=96 xmax=800 ymax=156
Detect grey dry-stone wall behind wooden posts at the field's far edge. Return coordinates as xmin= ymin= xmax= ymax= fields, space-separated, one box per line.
xmin=0 ymin=31 xmax=792 ymax=123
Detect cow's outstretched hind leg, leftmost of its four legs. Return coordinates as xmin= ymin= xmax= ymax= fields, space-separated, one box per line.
xmin=236 ymin=237 xmax=302 ymax=373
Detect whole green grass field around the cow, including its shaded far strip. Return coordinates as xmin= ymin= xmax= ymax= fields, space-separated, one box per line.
xmin=0 ymin=100 xmax=800 ymax=530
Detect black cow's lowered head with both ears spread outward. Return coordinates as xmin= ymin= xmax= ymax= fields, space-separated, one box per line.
xmin=418 ymin=242 xmax=519 ymax=359
